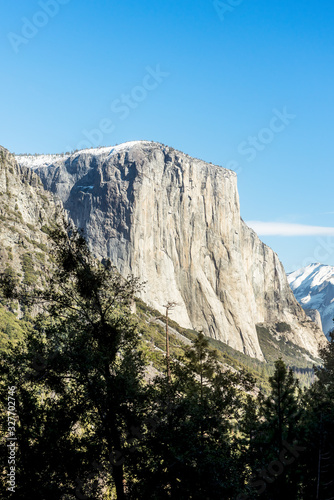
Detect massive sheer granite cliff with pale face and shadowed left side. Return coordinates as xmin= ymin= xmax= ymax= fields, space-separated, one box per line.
xmin=19 ymin=142 xmax=322 ymax=359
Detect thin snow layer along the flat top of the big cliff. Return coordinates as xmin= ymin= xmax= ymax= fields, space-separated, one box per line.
xmin=16 ymin=141 xmax=151 ymax=170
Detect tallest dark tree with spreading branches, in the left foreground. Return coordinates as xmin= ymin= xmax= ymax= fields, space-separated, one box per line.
xmin=0 ymin=229 xmax=144 ymax=499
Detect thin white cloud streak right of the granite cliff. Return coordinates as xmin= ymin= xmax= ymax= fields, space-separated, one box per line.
xmin=246 ymin=220 xmax=334 ymax=236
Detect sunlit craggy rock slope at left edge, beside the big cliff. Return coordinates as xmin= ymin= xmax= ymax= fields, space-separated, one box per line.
xmin=0 ymin=146 xmax=63 ymax=284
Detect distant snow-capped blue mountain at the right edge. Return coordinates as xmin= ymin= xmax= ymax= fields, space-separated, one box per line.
xmin=288 ymin=263 xmax=334 ymax=336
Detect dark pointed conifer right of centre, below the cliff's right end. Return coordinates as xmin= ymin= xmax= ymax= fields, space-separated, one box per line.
xmin=240 ymin=359 xmax=300 ymax=500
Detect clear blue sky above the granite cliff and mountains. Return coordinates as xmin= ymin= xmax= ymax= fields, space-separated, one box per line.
xmin=0 ymin=0 xmax=334 ymax=271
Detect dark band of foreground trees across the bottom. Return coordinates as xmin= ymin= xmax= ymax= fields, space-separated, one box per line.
xmin=0 ymin=227 xmax=334 ymax=500
